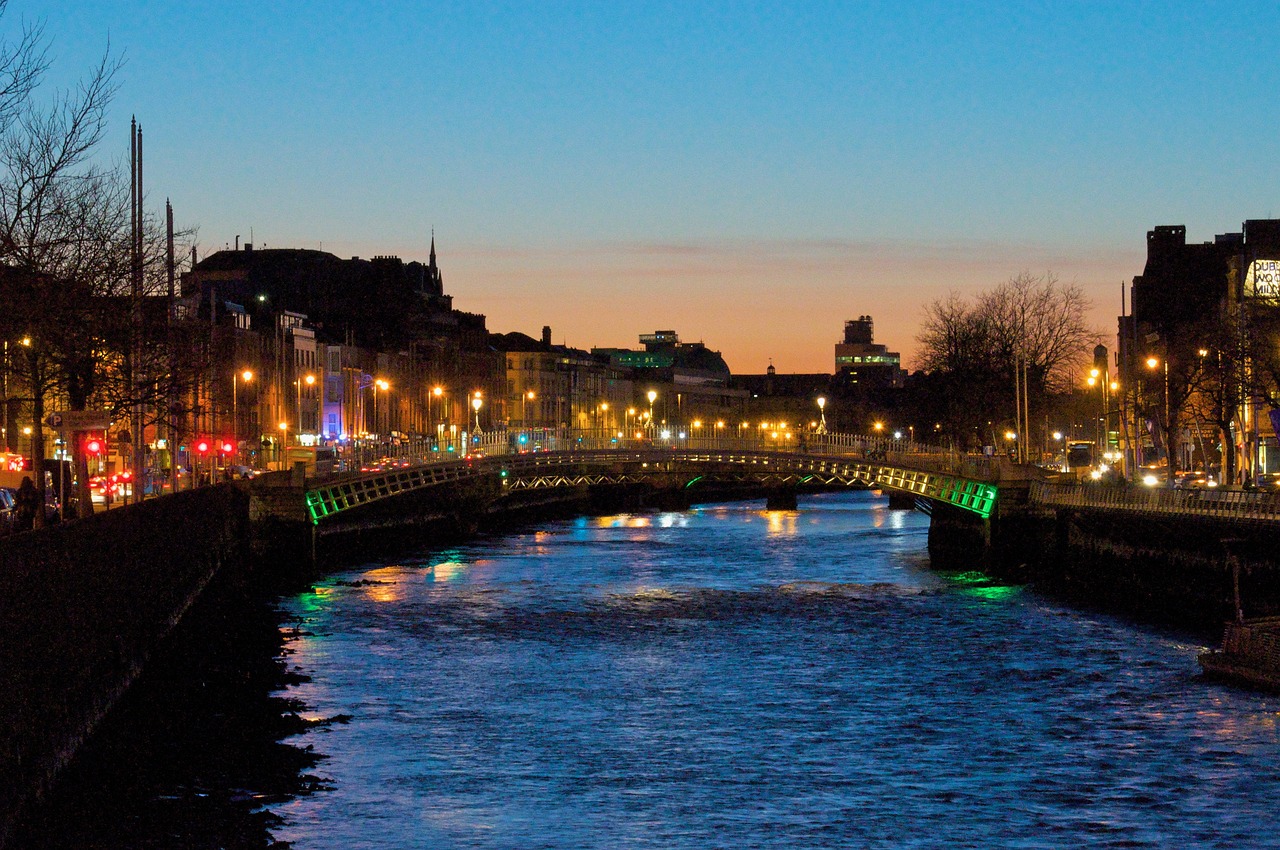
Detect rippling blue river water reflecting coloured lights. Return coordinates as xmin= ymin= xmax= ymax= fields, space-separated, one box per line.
xmin=271 ymin=493 xmax=1280 ymax=850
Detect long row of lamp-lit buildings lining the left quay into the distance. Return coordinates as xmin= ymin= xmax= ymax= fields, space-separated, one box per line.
xmin=165 ymin=237 xmax=905 ymax=460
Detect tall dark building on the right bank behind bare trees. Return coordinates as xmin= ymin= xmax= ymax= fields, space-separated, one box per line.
xmin=1117 ymin=219 xmax=1280 ymax=483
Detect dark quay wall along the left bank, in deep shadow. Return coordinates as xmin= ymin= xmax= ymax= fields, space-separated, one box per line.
xmin=0 ymin=485 xmax=248 ymax=846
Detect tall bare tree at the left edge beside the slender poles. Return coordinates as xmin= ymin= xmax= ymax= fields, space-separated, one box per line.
xmin=0 ymin=8 xmax=120 ymax=521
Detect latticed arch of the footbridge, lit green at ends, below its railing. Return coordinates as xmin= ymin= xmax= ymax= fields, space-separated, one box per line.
xmin=306 ymin=451 xmax=998 ymax=524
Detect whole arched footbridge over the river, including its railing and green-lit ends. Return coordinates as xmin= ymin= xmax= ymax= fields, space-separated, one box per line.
xmin=306 ymin=435 xmax=1008 ymax=525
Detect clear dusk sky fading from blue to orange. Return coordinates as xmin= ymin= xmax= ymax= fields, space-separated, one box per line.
xmin=20 ymin=0 xmax=1280 ymax=374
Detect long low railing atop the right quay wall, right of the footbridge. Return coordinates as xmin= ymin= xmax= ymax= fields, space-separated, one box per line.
xmin=1030 ymin=481 xmax=1280 ymax=522
